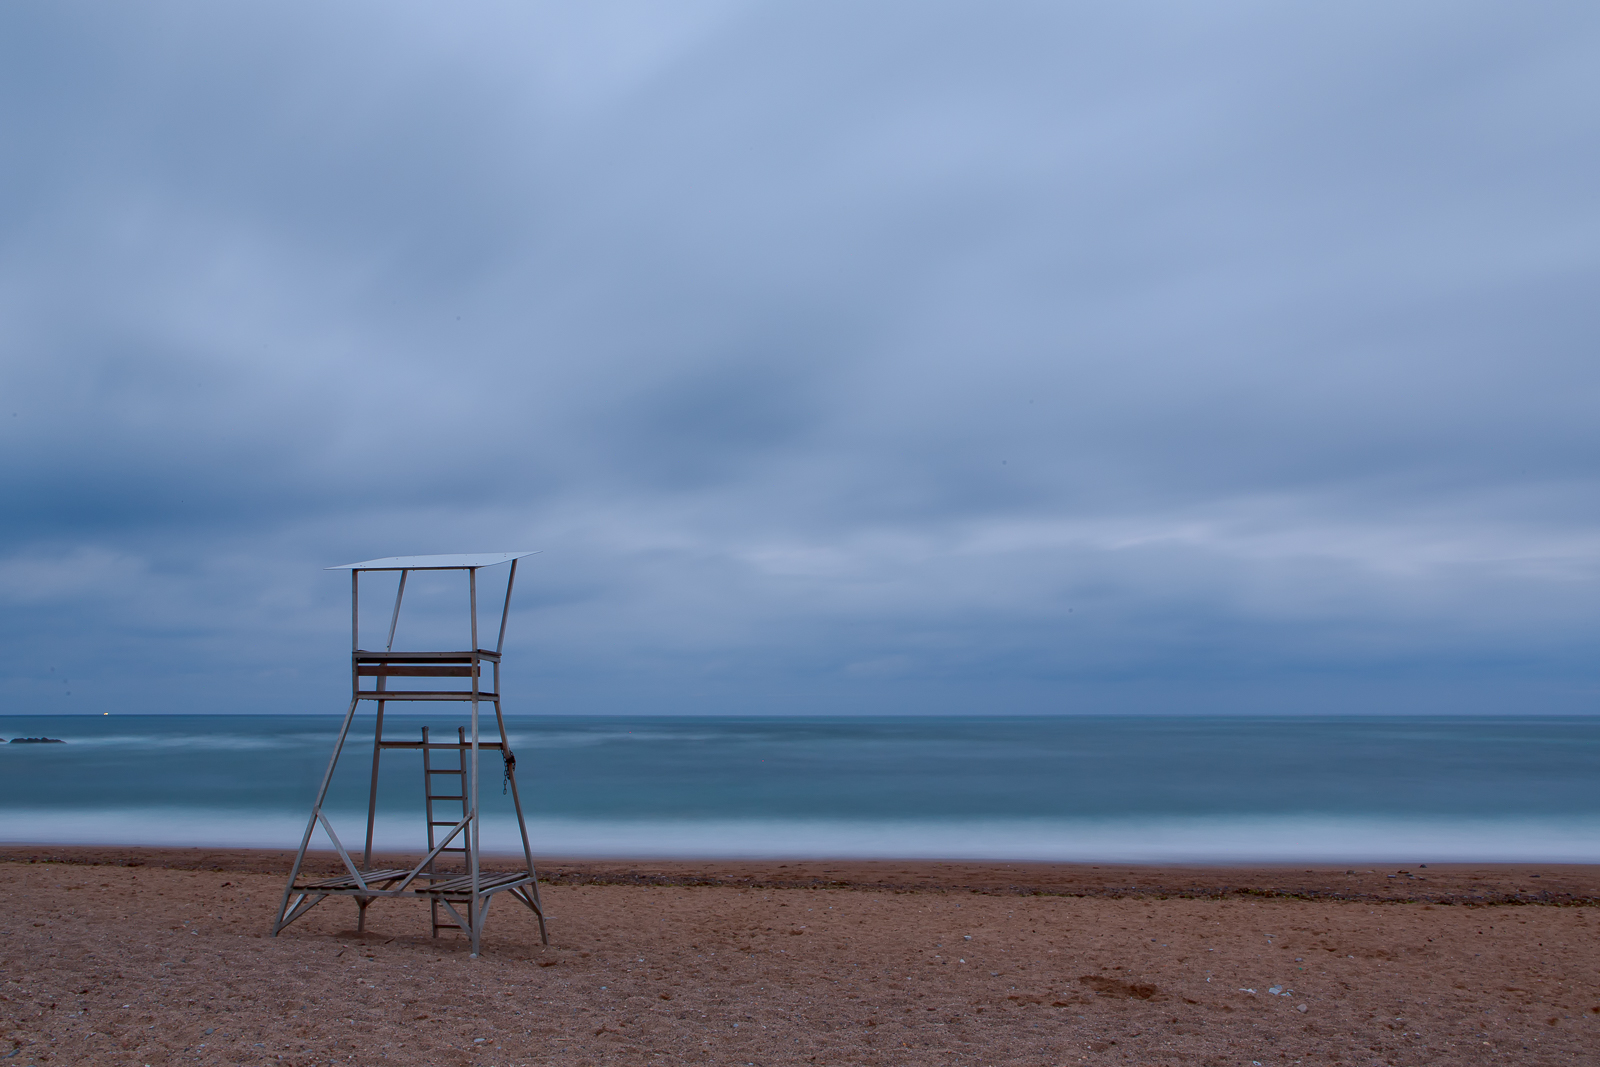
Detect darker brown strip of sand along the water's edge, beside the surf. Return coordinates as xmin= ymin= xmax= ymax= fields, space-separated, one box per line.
xmin=0 ymin=845 xmax=1600 ymax=907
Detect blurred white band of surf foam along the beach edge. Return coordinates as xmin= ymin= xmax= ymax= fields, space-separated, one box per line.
xmin=0 ymin=808 xmax=1600 ymax=864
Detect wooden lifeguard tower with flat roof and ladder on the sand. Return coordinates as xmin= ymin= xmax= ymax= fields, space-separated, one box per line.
xmin=272 ymin=552 xmax=550 ymax=957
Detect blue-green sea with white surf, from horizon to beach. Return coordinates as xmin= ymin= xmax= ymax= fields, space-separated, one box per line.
xmin=0 ymin=710 xmax=1600 ymax=862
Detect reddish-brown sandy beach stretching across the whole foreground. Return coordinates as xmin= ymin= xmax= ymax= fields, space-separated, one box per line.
xmin=0 ymin=848 xmax=1600 ymax=1067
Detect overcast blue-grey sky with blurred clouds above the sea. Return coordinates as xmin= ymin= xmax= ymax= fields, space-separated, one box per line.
xmin=0 ymin=0 xmax=1600 ymax=713
